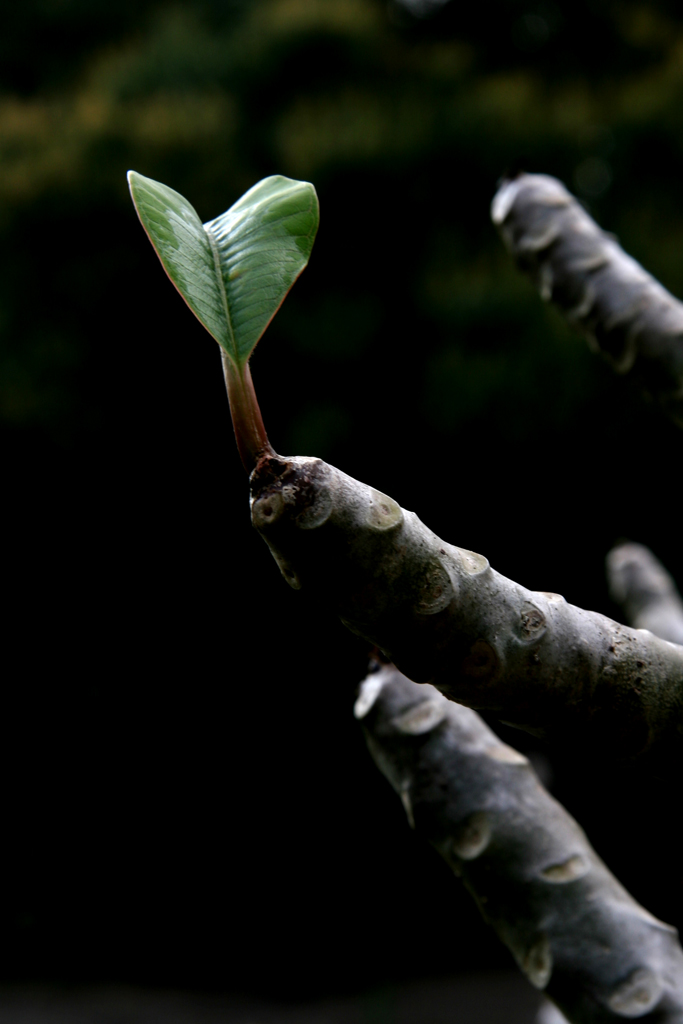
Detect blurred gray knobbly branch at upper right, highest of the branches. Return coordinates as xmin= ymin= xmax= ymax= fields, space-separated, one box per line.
xmin=492 ymin=174 xmax=683 ymax=426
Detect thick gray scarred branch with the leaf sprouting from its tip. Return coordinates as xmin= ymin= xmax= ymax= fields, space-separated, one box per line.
xmin=251 ymin=457 xmax=683 ymax=768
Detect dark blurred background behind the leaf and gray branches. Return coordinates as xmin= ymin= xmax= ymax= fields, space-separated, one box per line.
xmin=5 ymin=0 xmax=683 ymax=998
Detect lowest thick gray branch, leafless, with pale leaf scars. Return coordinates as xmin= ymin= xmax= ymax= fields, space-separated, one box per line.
xmin=355 ymin=667 xmax=683 ymax=1024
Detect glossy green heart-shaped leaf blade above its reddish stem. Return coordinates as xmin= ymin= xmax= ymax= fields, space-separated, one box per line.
xmin=128 ymin=171 xmax=318 ymax=368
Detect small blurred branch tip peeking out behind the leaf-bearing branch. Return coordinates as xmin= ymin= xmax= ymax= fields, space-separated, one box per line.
xmin=607 ymin=544 xmax=683 ymax=644
